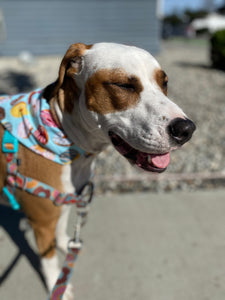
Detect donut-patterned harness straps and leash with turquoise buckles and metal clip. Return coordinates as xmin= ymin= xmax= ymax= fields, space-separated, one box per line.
xmin=2 ymin=130 xmax=94 ymax=300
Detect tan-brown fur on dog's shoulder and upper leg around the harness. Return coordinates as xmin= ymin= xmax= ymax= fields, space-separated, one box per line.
xmin=0 ymin=126 xmax=63 ymax=257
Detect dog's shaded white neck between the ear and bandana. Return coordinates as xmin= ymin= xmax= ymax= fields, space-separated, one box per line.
xmin=51 ymin=95 xmax=110 ymax=154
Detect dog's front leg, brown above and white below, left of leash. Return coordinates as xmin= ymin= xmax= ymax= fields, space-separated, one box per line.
xmin=17 ymin=190 xmax=73 ymax=300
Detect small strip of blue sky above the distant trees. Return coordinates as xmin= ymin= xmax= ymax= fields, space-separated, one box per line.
xmin=162 ymin=0 xmax=225 ymax=14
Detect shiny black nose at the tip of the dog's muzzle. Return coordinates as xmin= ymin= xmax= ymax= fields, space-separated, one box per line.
xmin=168 ymin=118 xmax=196 ymax=145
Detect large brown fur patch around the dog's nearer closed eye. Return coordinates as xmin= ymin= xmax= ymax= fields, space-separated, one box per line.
xmin=86 ymin=69 xmax=143 ymax=114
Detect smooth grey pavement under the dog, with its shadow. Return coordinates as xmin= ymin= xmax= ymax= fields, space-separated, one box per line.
xmin=0 ymin=189 xmax=225 ymax=300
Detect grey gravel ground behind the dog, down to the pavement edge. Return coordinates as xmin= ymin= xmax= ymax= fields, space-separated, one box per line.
xmin=0 ymin=41 xmax=225 ymax=192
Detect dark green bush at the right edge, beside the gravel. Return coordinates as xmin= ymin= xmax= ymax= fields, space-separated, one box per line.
xmin=210 ymin=30 xmax=225 ymax=70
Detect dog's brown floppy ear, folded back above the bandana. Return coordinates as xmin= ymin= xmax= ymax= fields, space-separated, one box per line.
xmin=43 ymin=43 xmax=92 ymax=119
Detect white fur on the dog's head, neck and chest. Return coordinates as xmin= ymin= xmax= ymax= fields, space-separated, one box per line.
xmin=56 ymin=43 xmax=189 ymax=260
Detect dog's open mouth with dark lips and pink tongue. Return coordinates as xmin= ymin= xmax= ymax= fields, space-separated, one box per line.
xmin=109 ymin=131 xmax=170 ymax=173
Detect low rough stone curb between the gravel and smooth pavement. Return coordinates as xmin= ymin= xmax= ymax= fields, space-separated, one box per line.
xmin=95 ymin=172 xmax=225 ymax=194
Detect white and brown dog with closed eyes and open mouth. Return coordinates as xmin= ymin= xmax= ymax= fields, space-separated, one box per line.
xmin=0 ymin=43 xmax=196 ymax=299
